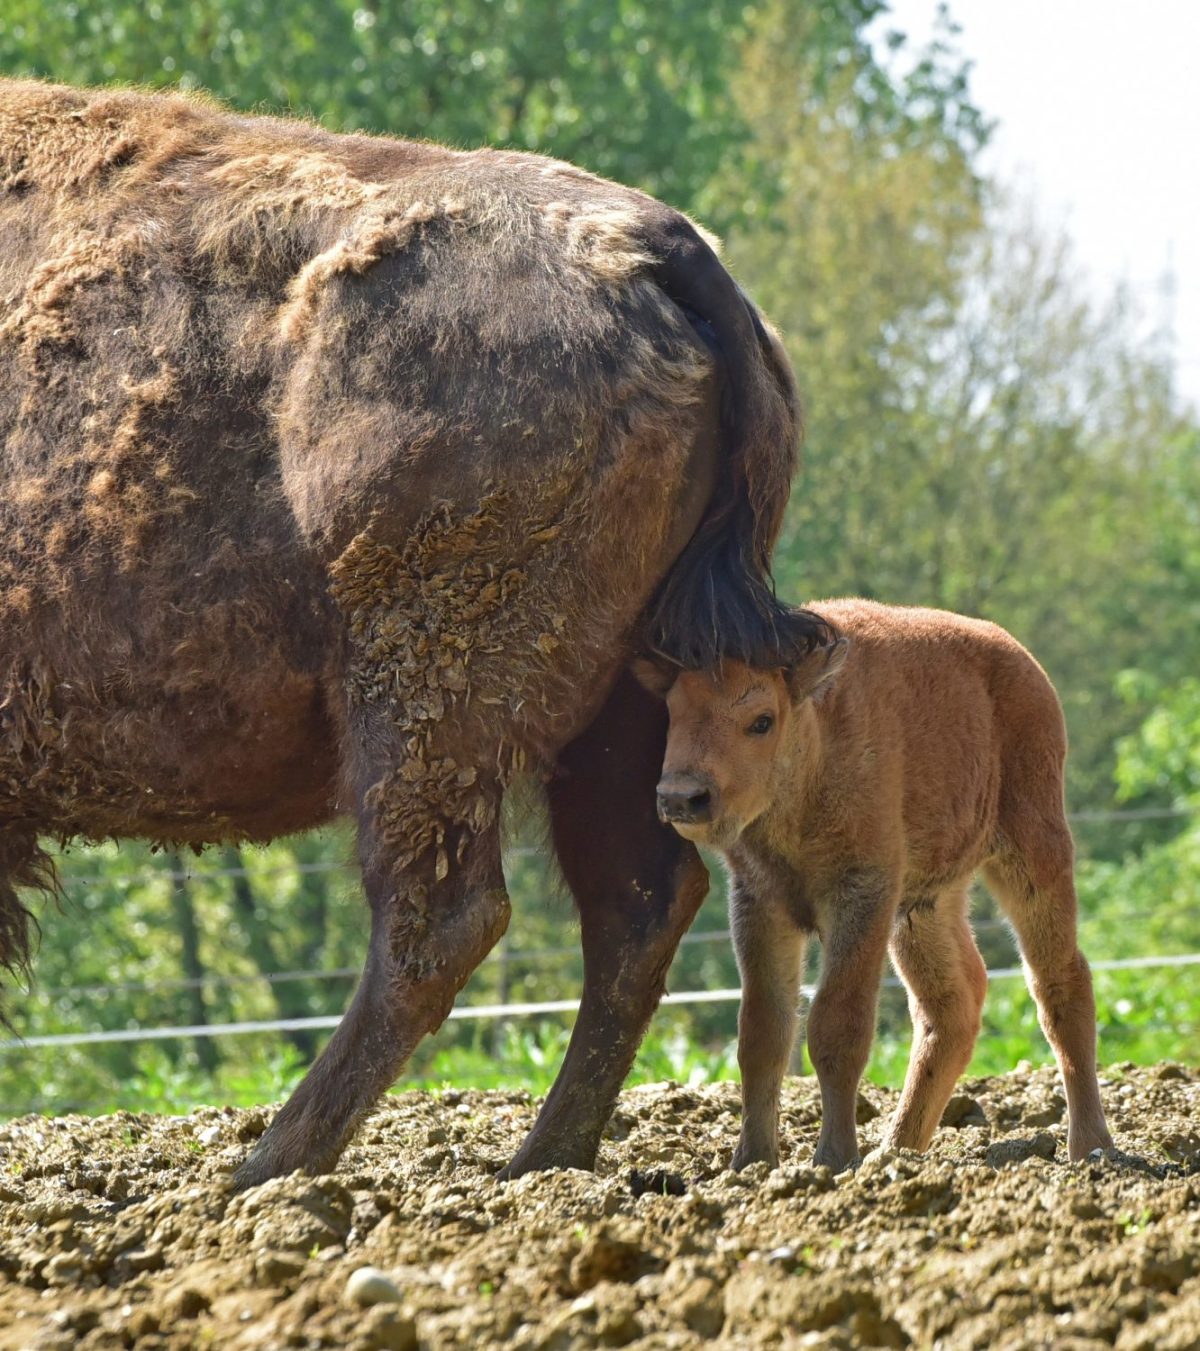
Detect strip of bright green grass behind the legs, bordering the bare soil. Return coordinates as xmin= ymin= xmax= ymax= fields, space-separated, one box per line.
xmin=0 ymin=969 xmax=1200 ymax=1116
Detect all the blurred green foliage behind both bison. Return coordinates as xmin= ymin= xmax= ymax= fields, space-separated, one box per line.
xmin=0 ymin=0 xmax=1200 ymax=1112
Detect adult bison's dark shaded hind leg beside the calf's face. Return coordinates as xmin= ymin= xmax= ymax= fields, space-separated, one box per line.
xmin=503 ymin=673 xmax=708 ymax=1178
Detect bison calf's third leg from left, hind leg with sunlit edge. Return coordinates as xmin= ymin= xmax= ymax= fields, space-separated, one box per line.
xmin=884 ymin=886 xmax=988 ymax=1150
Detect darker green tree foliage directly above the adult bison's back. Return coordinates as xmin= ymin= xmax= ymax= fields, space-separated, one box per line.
xmin=0 ymin=0 xmax=978 ymax=228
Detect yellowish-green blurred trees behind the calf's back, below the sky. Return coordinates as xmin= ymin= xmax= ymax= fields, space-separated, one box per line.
xmin=731 ymin=30 xmax=1200 ymax=816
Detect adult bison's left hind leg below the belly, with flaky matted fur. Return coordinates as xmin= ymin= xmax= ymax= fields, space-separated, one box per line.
xmin=234 ymin=771 xmax=509 ymax=1188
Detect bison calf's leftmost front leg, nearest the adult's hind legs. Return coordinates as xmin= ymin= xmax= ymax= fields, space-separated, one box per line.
xmin=731 ymin=890 xmax=805 ymax=1169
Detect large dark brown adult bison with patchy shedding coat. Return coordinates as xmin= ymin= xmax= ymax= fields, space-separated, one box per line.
xmin=0 ymin=84 xmax=809 ymax=1183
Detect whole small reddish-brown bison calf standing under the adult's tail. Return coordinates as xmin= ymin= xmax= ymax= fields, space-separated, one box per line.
xmin=638 ymin=600 xmax=1112 ymax=1170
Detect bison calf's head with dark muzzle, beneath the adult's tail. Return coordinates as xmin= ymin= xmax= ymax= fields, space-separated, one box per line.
xmin=634 ymin=638 xmax=847 ymax=848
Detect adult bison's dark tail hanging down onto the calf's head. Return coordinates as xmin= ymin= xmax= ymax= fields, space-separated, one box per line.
xmin=642 ymin=215 xmax=832 ymax=670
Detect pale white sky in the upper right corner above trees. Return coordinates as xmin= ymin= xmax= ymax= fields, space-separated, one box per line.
xmin=884 ymin=0 xmax=1200 ymax=408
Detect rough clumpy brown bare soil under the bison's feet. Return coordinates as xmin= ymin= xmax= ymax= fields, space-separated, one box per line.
xmin=0 ymin=1065 xmax=1200 ymax=1351
